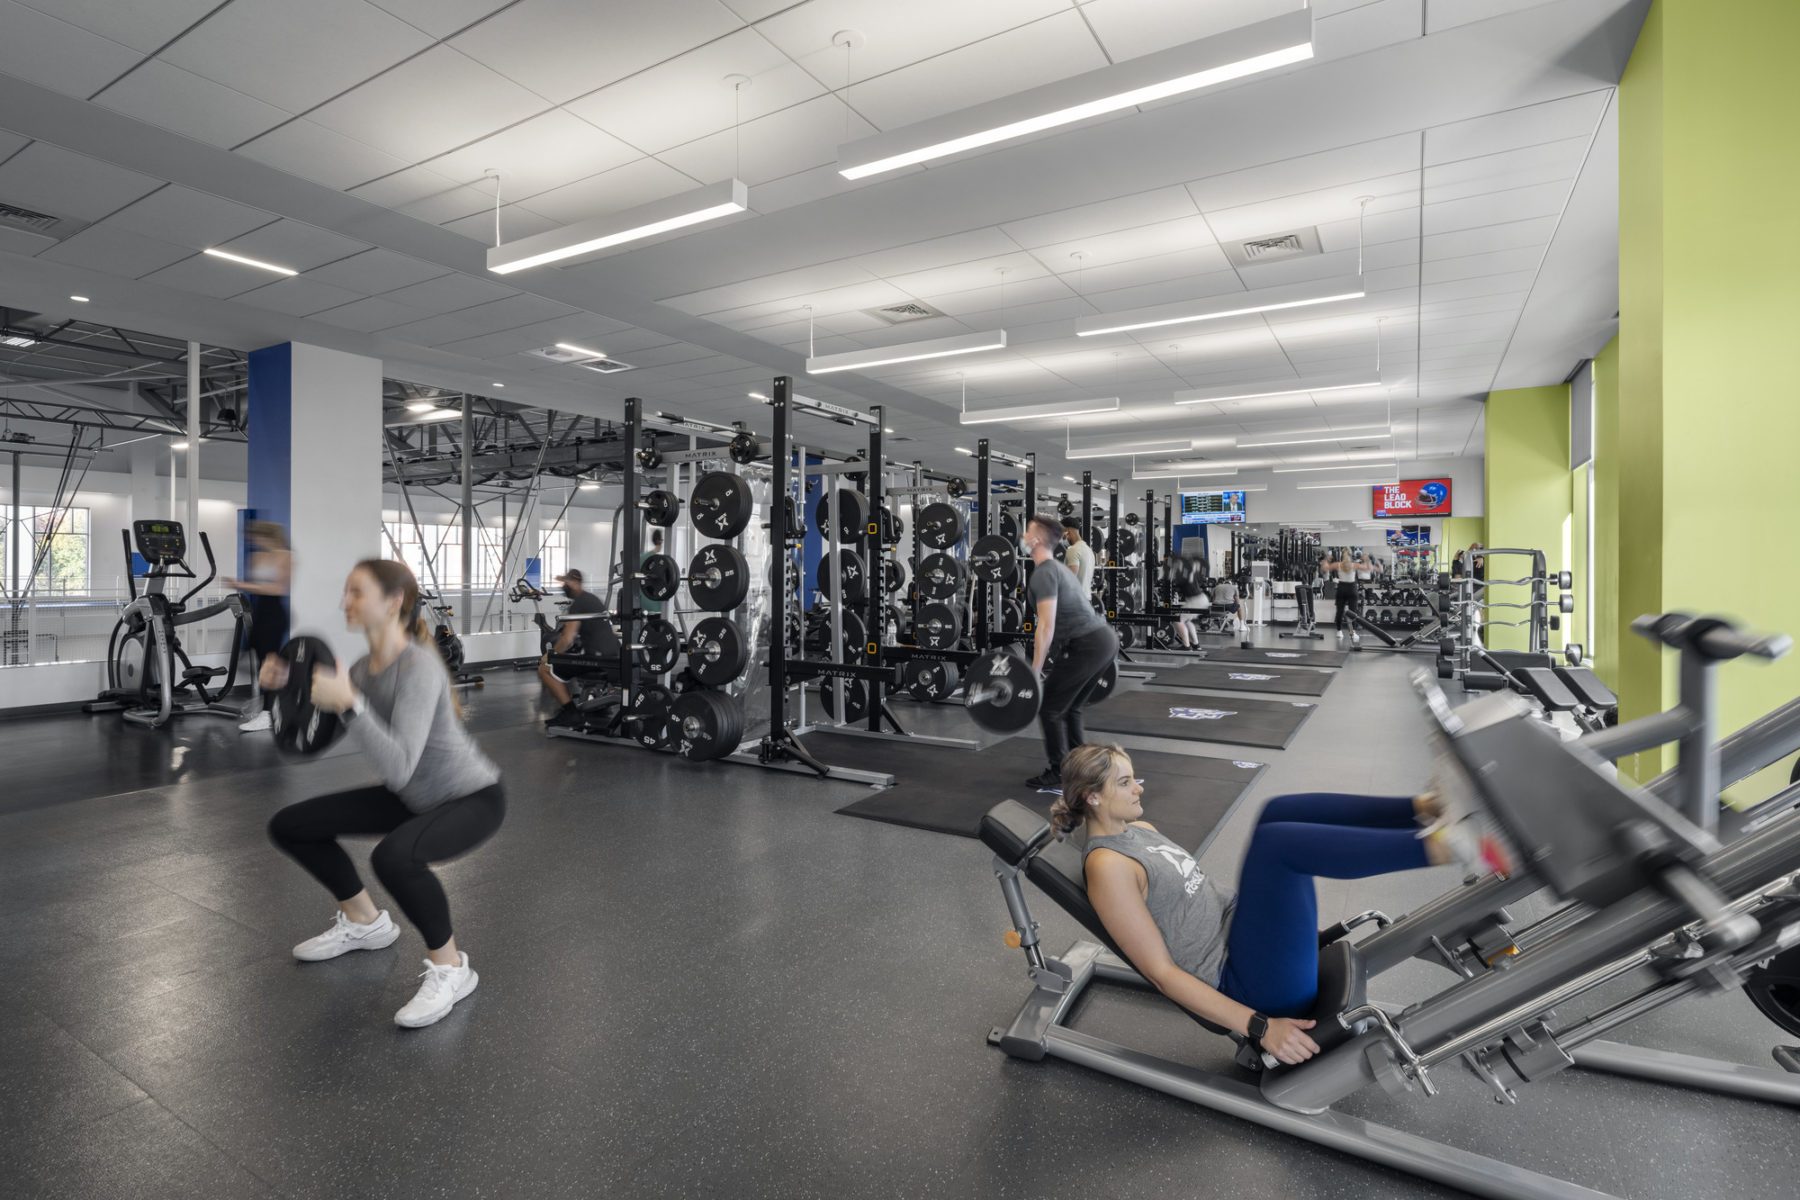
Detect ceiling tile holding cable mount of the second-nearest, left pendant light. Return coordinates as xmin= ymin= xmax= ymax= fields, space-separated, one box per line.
xmin=567 ymin=29 xmax=828 ymax=155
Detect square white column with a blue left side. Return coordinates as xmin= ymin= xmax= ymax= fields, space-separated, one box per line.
xmin=247 ymin=342 xmax=387 ymax=662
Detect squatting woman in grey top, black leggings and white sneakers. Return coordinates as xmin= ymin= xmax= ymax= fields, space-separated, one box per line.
xmin=261 ymin=558 xmax=506 ymax=1029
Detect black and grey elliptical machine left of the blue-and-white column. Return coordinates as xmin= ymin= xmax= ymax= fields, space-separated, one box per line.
xmin=81 ymin=520 xmax=250 ymax=729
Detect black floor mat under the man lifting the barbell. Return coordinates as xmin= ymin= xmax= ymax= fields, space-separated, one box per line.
xmin=824 ymin=734 xmax=1264 ymax=855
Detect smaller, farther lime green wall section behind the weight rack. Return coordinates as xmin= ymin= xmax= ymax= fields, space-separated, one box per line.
xmin=1483 ymin=383 xmax=1573 ymax=649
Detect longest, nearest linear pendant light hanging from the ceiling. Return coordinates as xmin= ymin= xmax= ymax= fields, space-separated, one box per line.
xmin=837 ymin=9 xmax=1312 ymax=180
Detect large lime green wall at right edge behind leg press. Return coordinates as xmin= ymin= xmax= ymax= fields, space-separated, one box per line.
xmin=1620 ymin=0 xmax=1800 ymax=801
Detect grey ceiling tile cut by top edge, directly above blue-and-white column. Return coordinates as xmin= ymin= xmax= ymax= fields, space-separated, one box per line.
xmin=162 ymin=0 xmax=432 ymax=112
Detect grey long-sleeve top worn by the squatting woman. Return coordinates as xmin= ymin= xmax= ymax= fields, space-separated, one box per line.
xmin=349 ymin=642 xmax=500 ymax=813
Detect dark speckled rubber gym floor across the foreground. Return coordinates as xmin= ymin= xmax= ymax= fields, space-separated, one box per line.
xmin=0 ymin=655 xmax=1800 ymax=1200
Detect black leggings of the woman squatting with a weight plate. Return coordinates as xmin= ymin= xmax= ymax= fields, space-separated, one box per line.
xmin=268 ymin=783 xmax=506 ymax=950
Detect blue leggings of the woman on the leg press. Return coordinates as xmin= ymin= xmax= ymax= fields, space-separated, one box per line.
xmin=1219 ymin=792 xmax=1431 ymax=1016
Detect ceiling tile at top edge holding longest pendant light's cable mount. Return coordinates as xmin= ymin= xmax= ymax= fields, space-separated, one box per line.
xmin=756 ymin=0 xmax=1069 ymax=92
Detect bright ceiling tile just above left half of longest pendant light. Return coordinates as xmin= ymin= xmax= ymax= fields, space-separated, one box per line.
xmin=839 ymin=9 xmax=1107 ymax=130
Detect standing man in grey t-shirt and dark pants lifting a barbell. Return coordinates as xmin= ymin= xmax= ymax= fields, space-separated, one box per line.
xmin=1024 ymin=515 xmax=1120 ymax=788
